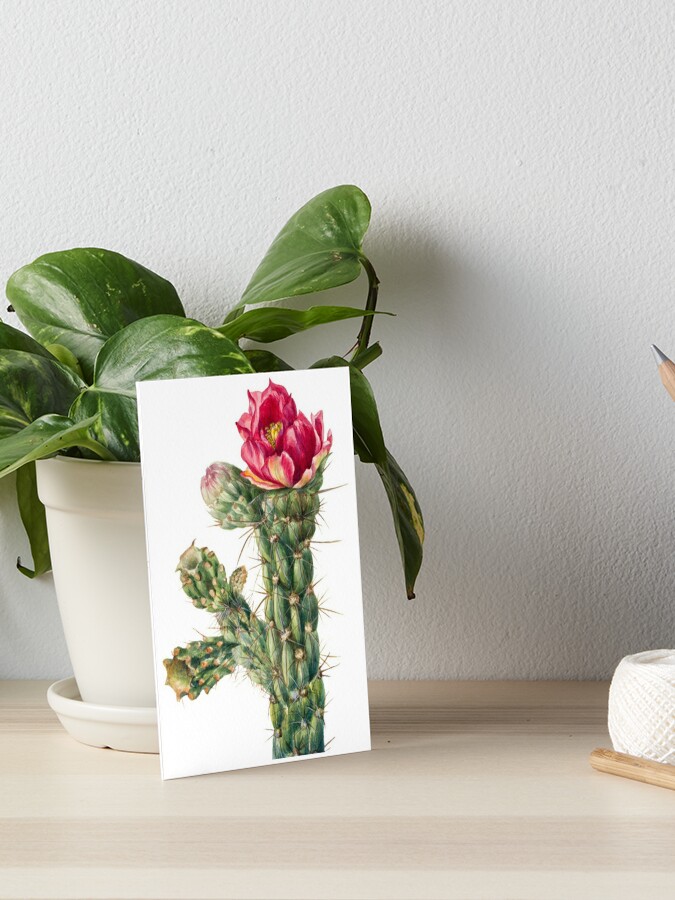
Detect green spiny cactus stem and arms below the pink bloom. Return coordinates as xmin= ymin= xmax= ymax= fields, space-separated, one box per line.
xmin=164 ymin=457 xmax=328 ymax=759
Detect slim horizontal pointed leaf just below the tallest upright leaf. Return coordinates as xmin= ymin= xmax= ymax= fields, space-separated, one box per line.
xmin=218 ymin=306 xmax=392 ymax=344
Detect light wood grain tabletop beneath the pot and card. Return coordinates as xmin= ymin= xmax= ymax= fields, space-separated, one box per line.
xmin=0 ymin=681 xmax=675 ymax=900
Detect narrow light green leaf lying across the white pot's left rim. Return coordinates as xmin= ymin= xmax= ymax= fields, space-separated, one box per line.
xmin=0 ymin=415 xmax=114 ymax=478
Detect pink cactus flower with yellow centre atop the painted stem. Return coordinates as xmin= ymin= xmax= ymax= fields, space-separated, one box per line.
xmin=237 ymin=380 xmax=333 ymax=490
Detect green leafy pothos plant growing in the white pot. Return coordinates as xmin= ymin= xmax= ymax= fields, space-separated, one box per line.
xmin=0 ymin=185 xmax=424 ymax=597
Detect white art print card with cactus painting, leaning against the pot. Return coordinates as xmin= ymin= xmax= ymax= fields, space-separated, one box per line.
xmin=137 ymin=368 xmax=370 ymax=778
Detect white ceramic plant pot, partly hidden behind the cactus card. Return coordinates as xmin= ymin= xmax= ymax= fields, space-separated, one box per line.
xmin=37 ymin=456 xmax=155 ymax=707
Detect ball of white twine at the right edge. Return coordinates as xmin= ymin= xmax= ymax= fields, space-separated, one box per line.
xmin=609 ymin=650 xmax=675 ymax=765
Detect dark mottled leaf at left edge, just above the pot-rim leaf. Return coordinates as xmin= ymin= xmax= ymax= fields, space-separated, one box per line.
xmin=0 ymin=350 xmax=85 ymax=439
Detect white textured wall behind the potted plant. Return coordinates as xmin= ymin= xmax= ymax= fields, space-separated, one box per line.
xmin=0 ymin=0 xmax=675 ymax=678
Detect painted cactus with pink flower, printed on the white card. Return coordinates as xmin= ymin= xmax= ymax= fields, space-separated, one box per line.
xmin=164 ymin=380 xmax=333 ymax=759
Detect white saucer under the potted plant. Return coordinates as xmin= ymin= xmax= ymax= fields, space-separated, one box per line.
xmin=47 ymin=678 xmax=159 ymax=753
